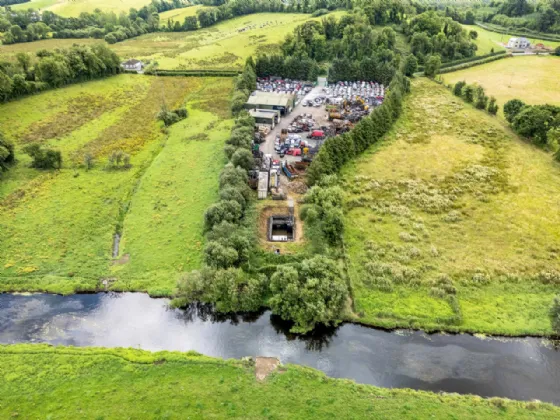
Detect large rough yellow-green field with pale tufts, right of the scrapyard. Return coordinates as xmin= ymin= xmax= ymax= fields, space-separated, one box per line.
xmin=344 ymin=79 xmax=560 ymax=335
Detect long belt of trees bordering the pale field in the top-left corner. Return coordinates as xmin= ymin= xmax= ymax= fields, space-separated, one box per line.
xmin=0 ymin=0 xmax=189 ymax=44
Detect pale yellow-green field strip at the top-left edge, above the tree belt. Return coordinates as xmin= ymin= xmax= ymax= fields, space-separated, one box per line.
xmin=12 ymin=0 xmax=151 ymax=17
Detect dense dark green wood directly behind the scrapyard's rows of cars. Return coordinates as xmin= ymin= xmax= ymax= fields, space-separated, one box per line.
xmin=256 ymin=10 xmax=403 ymax=84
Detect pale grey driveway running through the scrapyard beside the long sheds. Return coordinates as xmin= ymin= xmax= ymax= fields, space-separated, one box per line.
xmin=260 ymin=86 xmax=328 ymax=162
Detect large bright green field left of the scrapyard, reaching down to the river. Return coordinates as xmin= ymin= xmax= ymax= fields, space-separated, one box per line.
xmin=0 ymin=75 xmax=231 ymax=294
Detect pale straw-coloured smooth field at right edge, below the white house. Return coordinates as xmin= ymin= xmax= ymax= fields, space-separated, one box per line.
xmin=443 ymin=55 xmax=560 ymax=116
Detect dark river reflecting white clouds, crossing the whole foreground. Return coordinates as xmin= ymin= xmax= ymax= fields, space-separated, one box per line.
xmin=0 ymin=293 xmax=560 ymax=404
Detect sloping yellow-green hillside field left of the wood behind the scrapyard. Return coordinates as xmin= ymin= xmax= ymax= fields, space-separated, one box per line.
xmin=111 ymin=12 xmax=344 ymax=69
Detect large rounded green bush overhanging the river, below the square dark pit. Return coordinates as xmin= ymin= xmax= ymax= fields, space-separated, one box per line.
xmin=269 ymin=256 xmax=348 ymax=333
